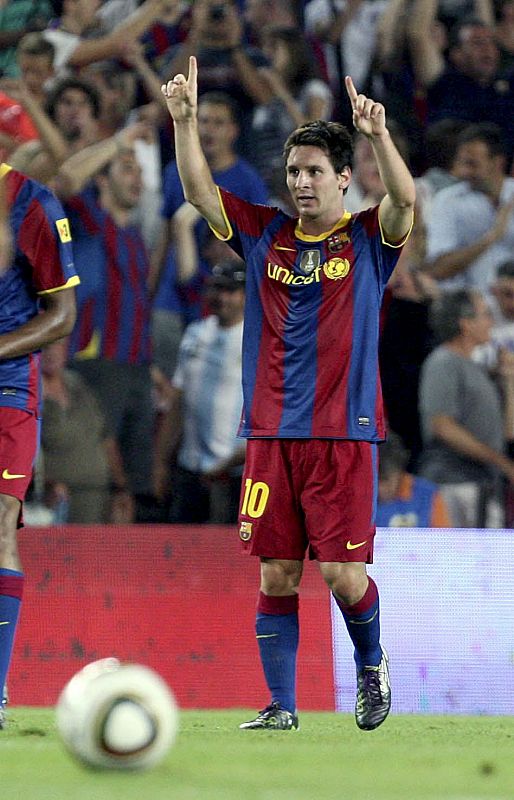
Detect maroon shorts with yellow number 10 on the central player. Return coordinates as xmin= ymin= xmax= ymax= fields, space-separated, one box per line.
xmin=239 ymin=439 xmax=377 ymax=564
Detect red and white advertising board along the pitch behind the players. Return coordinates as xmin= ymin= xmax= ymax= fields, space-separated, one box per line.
xmin=9 ymin=525 xmax=514 ymax=714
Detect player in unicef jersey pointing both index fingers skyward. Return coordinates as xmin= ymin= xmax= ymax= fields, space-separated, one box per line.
xmin=162 ymin=58 xmax=415 ymax=730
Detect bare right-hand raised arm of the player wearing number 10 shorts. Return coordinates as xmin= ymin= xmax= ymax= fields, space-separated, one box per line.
xmin=345 ymin=76 xmax=416 ymax=243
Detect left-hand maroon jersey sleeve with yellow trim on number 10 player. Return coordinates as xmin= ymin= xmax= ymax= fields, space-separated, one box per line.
xmin=211 ymin=187 xmax=281 ymax=259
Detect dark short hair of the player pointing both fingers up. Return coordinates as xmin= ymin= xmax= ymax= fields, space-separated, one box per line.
xmin=283 ymin=119 xmax=353 ymax=174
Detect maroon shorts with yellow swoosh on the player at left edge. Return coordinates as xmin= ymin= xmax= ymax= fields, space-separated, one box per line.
xmin=0 ymin=406 xmax=39 ymax=501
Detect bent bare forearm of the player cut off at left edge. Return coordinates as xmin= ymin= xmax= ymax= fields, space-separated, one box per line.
xmin=0 ymin=288 xmax=76 ymax=359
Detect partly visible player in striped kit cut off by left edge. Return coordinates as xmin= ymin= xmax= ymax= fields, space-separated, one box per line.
xmin=0 ymin=164 xmax=78 ymax=728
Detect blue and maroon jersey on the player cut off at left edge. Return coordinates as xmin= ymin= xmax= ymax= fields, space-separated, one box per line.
xmin=0 ymin=164 xmax=79 ymax=414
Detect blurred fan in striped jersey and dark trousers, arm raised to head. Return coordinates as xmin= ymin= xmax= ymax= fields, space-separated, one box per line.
xmin=61 ymin=146 xmax=155 ymax=522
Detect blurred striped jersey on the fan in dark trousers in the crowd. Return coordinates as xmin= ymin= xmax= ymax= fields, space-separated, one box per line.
xmin=66 ymin=188 xmax=151 ymax=364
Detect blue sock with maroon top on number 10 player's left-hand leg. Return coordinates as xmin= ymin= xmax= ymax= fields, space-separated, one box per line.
xmin=255 ymin=592 xmax=299 ymax=712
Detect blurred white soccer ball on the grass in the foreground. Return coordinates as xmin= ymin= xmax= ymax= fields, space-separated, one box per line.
xmin=56 ymin=658 xmax=178 ymax=769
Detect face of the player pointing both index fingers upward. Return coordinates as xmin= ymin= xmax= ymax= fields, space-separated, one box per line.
xmin=286 ymin=145 xmax=351 ymax=233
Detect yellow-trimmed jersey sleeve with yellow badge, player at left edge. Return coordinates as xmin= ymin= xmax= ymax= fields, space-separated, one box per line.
xmin=17 ymin=186 xmax=80 ymax=295
